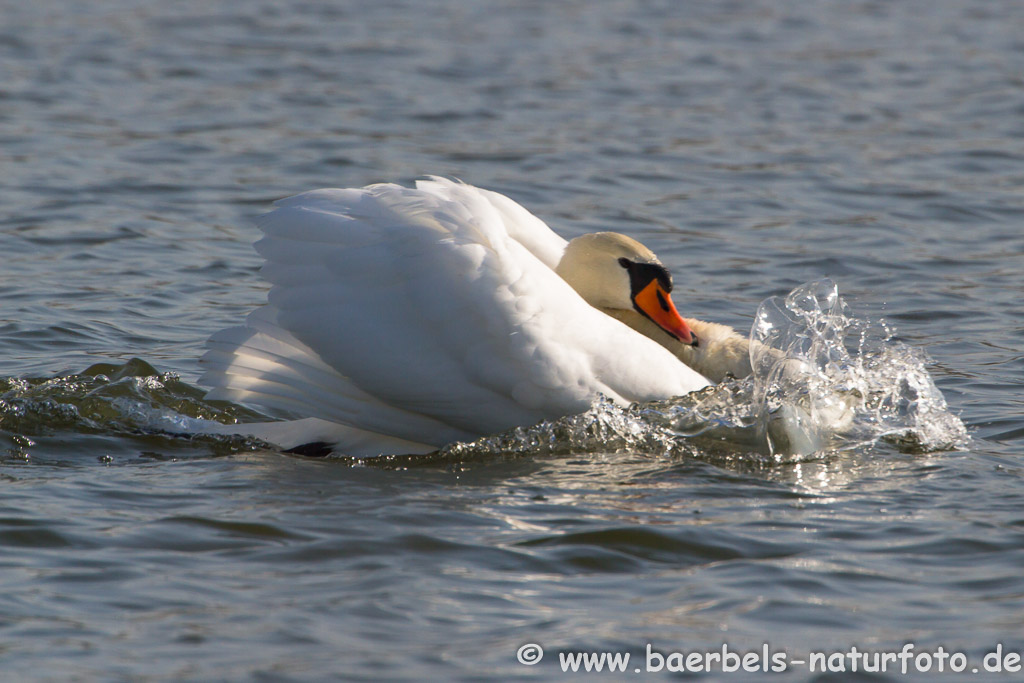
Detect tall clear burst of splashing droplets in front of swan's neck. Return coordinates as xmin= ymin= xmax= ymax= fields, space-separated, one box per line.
xmin=751 ymin=280 xmax=967 ymax=453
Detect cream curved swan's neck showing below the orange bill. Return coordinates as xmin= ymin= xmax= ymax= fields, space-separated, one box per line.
xmin=602 ymin=308 xmax=751 ymax=382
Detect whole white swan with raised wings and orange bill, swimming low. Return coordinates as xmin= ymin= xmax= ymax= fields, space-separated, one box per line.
xmin=201 ymin=178 xmax=749 ymax=456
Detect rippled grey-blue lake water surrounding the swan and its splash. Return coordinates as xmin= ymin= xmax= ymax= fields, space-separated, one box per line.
xmin=0 ymin=0 xmax=1024 ymax=681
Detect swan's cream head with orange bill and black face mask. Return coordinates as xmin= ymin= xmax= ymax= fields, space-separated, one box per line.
xmin=555 ymin=232 xmax=697 ymax=346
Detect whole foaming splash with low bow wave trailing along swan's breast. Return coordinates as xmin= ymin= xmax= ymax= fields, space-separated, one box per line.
xmin=445 ymin=280 xmax=967 ymax=462
